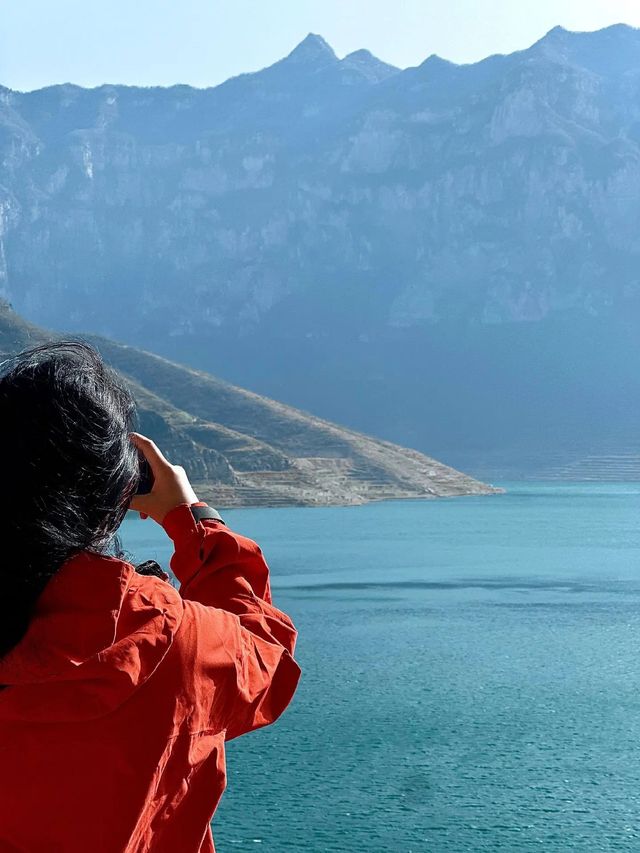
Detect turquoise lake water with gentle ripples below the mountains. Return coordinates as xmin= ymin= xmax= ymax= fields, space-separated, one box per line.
xmin=116 ymin=483 xmax=640 ymax=853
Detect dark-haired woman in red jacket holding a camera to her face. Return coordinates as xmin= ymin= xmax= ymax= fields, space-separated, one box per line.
xmin=0 ymin=342 xmax=300 ymax=853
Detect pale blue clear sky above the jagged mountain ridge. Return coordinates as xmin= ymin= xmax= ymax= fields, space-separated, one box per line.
xmin=0 ymin=0 xmax=640 ymax=91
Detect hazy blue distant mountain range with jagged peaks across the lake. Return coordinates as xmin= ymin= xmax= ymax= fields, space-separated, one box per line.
xmin=0 ymin=25 xmax=640 ymax=471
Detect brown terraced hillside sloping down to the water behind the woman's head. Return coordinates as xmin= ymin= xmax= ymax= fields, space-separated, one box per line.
xmin=0 ymin=303 xmax=498 ymax=506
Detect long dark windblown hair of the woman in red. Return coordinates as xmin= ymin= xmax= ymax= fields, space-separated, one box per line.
xmin=0 ymin=341 xmax=140 ymax=656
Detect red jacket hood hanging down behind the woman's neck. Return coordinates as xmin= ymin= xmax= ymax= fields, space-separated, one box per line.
xmin=0 ymin=552 xmax=183 ymax=723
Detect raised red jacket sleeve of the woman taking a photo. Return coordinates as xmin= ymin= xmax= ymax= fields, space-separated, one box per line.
xmin=162 ymin=504 xmax=301 ymax=740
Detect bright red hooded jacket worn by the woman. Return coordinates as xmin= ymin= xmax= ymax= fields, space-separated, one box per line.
xmin=0 ymin=504 xmax=301 ymax=853
